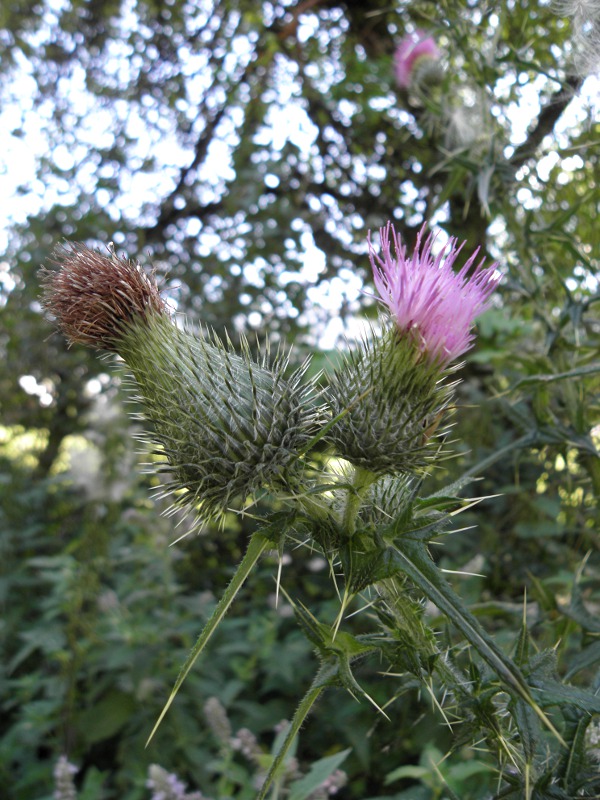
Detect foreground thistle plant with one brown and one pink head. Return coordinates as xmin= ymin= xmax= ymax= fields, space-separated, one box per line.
xmin=42 ymin=224 xmax=600 ymax=798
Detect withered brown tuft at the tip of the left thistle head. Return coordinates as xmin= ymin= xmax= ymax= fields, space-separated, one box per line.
xmin=40 ymin=242 xmax=168 ymax=352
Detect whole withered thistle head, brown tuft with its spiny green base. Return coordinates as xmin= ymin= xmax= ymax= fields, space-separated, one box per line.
xmin=42 ymin=245 xmax=318 ymax=522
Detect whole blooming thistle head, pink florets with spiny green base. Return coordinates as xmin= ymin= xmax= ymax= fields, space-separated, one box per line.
xmin=328 ymin=224 xmax=499 ymax=474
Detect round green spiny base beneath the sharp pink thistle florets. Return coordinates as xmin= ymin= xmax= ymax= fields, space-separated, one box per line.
xmin=326 ymin=328 xmax=452 ymax=475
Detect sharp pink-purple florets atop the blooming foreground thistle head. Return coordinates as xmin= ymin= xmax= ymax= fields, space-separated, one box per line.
xmin=368 ymin=222 xmax=500 ymax=367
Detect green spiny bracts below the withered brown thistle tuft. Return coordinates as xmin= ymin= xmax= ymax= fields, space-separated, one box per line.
xmin=119 ymin=316 xmax=318 ymax=520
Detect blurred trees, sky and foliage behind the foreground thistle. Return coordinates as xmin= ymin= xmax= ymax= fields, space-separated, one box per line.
xmin=0 ymin=0 xmax=600 ymax=800
